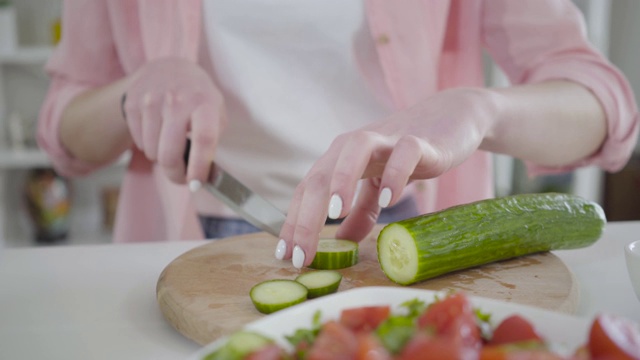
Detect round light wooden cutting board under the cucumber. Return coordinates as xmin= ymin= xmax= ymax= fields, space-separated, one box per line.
xmin=156 ymin=226 xmax=578 ymax=345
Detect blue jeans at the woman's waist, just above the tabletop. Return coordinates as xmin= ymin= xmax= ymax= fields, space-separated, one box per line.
xmin=199 ymin=197 xmax=418 ymax=239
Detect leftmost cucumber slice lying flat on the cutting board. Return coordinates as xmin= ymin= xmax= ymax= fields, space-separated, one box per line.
xmin=249 ymin=279 xmax=309 ymax=314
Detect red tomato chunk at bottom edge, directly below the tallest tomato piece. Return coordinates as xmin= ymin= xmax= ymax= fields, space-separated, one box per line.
xmin=397 ymin=332 xmax=479 ymax=360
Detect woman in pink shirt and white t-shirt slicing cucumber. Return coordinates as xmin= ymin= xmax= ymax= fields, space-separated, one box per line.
xmin=38 ymin=0 xmax=638 ymax=268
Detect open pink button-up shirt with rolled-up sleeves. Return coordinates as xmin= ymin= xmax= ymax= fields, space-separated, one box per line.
xmin=38 ymin=0 xmax=639 ymax=241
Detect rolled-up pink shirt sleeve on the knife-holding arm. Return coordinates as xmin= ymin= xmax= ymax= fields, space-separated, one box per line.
xmin=36 ymin=0 xmax=123 ymax=176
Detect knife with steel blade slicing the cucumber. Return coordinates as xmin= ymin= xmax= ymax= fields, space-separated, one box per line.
xmin=184 ymin=139 xmax=286 ymax=237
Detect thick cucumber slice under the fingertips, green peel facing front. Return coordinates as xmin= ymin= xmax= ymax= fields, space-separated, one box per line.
xmin=309 ymin=239 xmax=358 ymax=270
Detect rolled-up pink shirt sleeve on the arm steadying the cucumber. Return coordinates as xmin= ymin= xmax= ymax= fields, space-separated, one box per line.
xmin=483 ymin=0 xmax=639 ymax=175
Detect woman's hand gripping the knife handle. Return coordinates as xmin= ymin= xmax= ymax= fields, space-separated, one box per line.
xmin=124 ymin=58 xmax=227 ymax=183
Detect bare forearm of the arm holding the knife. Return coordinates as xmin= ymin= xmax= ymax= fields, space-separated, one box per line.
xmin=60 ymin=79 xmax=132 ymax=164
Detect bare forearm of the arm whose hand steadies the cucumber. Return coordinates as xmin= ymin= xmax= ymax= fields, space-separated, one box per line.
xmin=480 ymin=81 xmax=607 ymax=166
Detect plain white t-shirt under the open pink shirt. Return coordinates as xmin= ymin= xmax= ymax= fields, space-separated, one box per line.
xmin=195 ymin=0 xmax=391 ymax=216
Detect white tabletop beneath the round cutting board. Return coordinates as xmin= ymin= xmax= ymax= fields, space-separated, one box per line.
xmin=0 ymin=221 xmax=640 ymax=360
